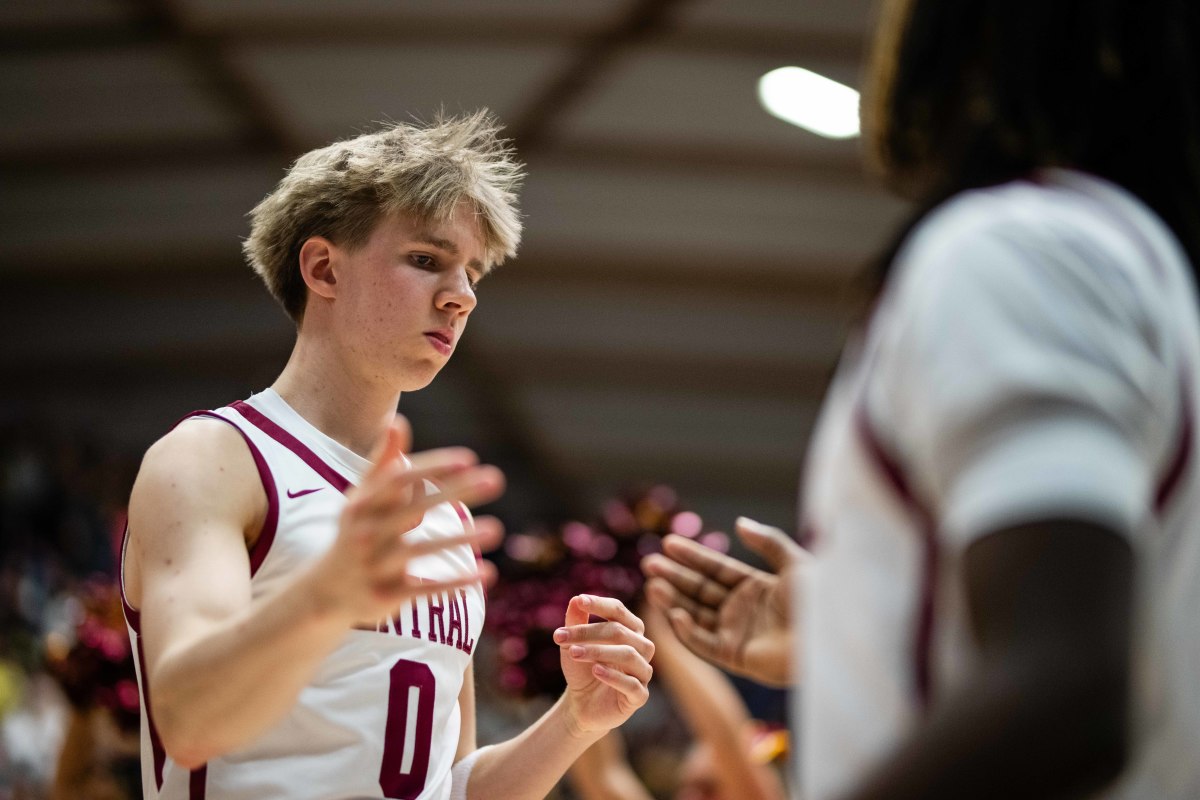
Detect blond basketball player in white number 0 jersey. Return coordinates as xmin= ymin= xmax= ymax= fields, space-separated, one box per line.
xmin=122 ymin=114 xmax=653 ymax=800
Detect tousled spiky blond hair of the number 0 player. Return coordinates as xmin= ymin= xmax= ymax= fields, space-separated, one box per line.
xmin=242 ymin=110 xmax=524 ymax=324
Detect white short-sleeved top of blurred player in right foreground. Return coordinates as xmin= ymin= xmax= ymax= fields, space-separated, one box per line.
xmin=796 ymin=170 xmax=1200 ymax=800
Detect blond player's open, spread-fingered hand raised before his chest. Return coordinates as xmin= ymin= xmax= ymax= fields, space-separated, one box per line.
xmin=312 ymin=417 xmax=504 ymax=621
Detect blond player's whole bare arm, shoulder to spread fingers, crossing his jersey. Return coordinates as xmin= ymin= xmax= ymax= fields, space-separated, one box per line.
xmin=127 ymin=421 xmax=502 ymax=768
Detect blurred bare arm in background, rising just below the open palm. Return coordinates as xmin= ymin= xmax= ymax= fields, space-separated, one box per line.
xmin=646 ymin=609 xmax=786 ymax=800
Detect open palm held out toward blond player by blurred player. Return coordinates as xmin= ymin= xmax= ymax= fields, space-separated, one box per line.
xmin=642 ymin=517 xmax=809 ymax=686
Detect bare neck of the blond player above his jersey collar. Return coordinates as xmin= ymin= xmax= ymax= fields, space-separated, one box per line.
xmin=271 ymin=331 xmax=400 ymax=458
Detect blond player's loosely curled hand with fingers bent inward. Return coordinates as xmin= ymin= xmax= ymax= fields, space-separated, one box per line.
xmin=554 ymin=595 xmax=654 ymax=734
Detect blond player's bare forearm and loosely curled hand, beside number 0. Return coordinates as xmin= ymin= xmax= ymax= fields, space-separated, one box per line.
xmin=460 ymin=595 xmax=654 ymax=800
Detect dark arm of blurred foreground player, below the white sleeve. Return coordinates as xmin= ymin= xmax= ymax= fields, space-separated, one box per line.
xmin=845 ymin=519 xmax=1134 ymax=800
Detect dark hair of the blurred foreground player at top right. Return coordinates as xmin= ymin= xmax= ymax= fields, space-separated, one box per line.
xmin=865 ymin=0 xmax=1200 ymax=286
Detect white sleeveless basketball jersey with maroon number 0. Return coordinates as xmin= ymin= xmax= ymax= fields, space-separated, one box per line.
xmin=118 ymin=390 xmax=484 ymax=800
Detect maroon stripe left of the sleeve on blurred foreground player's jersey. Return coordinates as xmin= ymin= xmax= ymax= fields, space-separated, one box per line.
xmin=854 ymin=403 xmax=941 ymax=709
